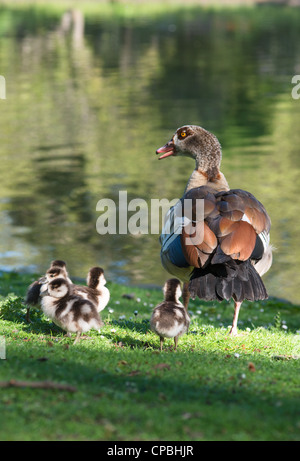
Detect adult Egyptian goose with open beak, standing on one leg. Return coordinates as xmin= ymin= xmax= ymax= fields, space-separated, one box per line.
xmin=156 ymin=125 xmax=272 ymax=335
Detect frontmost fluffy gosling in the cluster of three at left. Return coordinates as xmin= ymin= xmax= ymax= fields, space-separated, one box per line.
xmin=40 ymin=278 xmax=103 ymax=344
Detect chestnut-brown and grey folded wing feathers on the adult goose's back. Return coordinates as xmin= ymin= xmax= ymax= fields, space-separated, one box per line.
xmin=181 ymin=186 xmax=270 ymax=268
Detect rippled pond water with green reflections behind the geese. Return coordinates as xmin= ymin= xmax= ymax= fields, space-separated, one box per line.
xmin=0 ymin=5 xmax=300 ymax=302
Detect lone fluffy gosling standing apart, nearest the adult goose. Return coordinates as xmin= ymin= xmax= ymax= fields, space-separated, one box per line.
xmin=150 ymin=279 xmax=190 ymax=351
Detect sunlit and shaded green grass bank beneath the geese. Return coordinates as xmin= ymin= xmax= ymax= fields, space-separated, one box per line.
xmin=0 ymin=274 xmax=300 ymax=441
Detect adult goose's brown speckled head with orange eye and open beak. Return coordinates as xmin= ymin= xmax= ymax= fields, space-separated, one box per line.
xmin=156 ymin=125 xmax=222 ymax=179
